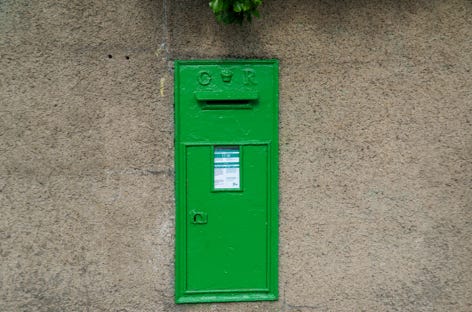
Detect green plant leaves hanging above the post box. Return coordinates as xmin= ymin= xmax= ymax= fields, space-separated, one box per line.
xmin=209 ymin=0 xmax=262 ymax=25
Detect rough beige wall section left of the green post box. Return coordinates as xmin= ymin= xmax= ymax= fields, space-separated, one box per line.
xmin=0 ymin=0 xmax=174 ymax=311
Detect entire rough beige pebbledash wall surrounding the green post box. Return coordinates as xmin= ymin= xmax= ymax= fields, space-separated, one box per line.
xmin=0 ymin=0 xmax=472 ymax=312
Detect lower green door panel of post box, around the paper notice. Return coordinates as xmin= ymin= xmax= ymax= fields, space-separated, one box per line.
xmin=186 ymin=146 xmax=269 ymax=292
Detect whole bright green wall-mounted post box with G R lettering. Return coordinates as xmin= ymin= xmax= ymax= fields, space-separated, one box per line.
xmin=175 ymin=60 xmax=278 ymax=303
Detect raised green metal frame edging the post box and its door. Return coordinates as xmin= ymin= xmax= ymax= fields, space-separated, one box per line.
xmin=174 ymin=59 xmax=279 ymax=303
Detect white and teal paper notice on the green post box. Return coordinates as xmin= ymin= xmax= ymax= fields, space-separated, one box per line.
xmin=214 ymin=147 xmax=240 ymax=190
